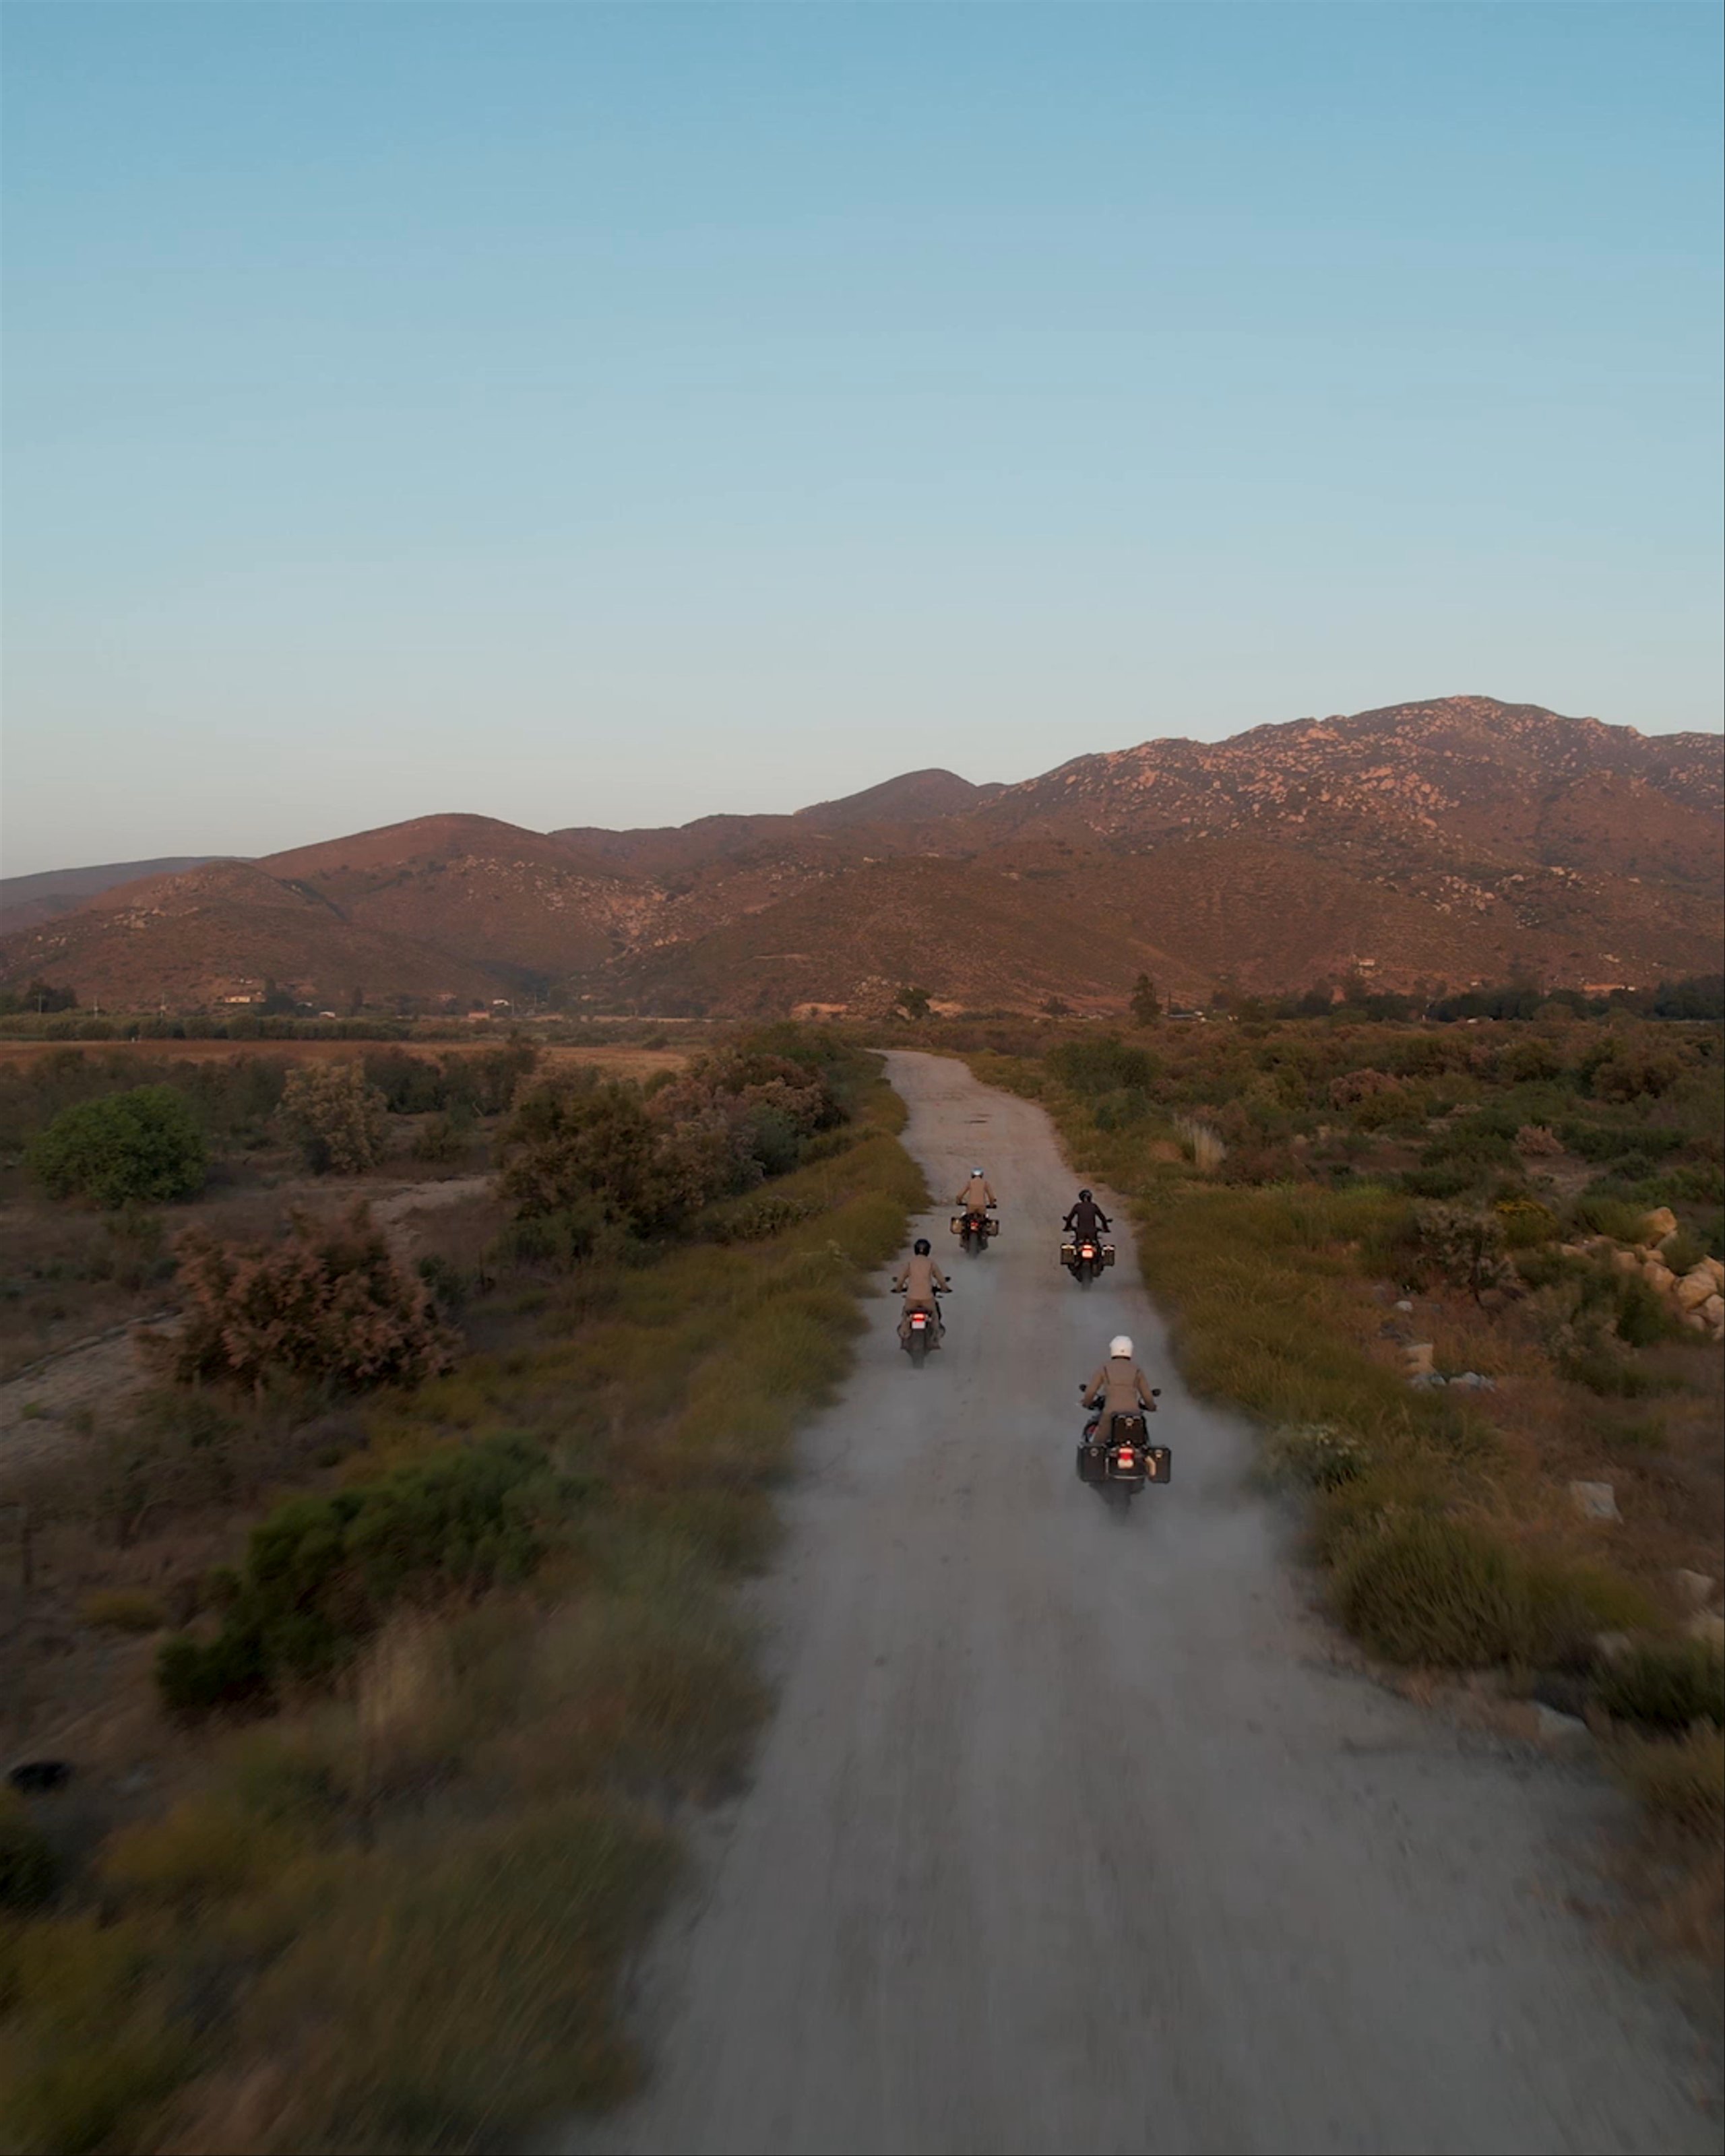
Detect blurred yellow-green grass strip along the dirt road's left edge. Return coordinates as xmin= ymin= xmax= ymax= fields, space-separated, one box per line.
xmin=0 ymin=1060 xmax=925 ymax=2152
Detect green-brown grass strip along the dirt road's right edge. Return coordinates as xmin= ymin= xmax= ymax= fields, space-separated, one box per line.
xmin=968 ymin=1042 xmax=1721 ymax=1958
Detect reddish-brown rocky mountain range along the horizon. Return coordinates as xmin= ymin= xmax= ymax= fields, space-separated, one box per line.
xmin=0 ymin=697 xmax=1725 ymax=1015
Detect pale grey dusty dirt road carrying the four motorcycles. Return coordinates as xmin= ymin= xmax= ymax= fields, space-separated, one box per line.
xmin=567 ymin=1054 xmax=1718 ymax=2156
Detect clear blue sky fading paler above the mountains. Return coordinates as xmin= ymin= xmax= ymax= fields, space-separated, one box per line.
xmin=2 ymin=0 xmax=1721 ymax=873
